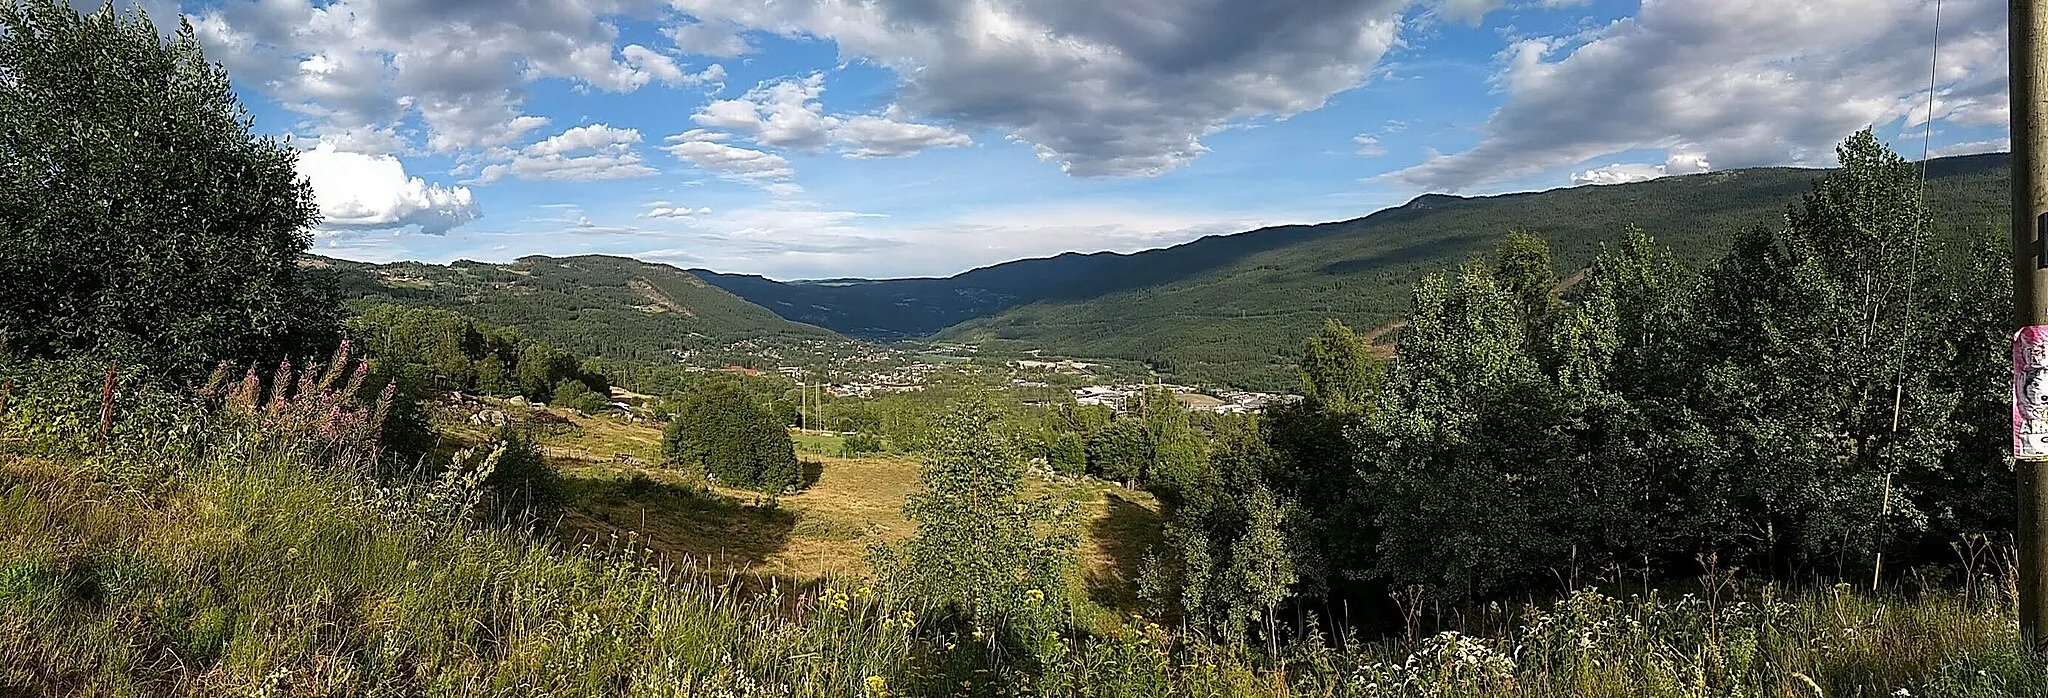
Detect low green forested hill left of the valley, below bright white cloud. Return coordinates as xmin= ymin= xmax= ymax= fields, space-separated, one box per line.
xmin=311 ymin=256 xmax=844 ymax=360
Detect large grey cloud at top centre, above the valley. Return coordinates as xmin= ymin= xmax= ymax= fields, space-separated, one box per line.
xmin=674 ymin=0 xmax=1413 ymax=176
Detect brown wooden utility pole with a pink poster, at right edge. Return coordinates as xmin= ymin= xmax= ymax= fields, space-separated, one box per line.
xmin=2007 ymin=0 xmax=2048 ymax=651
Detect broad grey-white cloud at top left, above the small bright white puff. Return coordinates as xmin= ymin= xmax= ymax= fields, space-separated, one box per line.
xmin=193 ymin=0 xmax=725 ymax=151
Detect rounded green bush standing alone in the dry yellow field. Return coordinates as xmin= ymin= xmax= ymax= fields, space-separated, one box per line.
xmin=662 ymin=383 xmax=801 ymax=493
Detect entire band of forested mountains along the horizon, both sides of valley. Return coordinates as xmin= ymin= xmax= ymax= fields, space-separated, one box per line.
xmin=311 ymin=154 xmax=2009 ymax=389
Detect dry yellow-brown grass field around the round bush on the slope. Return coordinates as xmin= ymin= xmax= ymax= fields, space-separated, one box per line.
xmin=436 ymin=399 xmax=1159 ymax=610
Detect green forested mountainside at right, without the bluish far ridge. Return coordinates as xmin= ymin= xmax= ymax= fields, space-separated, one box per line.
xmin=909 ymin=156 xmax=1982 ymax=389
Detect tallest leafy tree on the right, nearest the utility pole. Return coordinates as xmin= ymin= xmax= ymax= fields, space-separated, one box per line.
xmin=1694 ymin=129 xmax=1960 ymax=571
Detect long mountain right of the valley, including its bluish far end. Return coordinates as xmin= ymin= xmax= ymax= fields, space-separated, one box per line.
xmin=698 ymin=154 xmax=2009 ymax=389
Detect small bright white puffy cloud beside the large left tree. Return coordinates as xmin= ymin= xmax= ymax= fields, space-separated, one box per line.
xmin=299 ymin=143 xmax=483 ymax=233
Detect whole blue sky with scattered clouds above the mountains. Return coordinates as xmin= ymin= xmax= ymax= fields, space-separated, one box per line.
xmin=108 ymin=0 xmax=2007 ymax=280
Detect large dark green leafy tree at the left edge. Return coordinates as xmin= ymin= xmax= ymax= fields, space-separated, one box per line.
xmin=0 ymin=0 xmax=340 ymax=375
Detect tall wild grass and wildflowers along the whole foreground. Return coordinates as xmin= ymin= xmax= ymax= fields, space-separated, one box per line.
xmin=0 ymin=362 xmax=2048 ymax=698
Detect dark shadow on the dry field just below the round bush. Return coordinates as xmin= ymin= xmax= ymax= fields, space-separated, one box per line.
xmin=561 ymin=475 xmax=797 ymax=569
